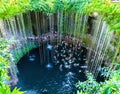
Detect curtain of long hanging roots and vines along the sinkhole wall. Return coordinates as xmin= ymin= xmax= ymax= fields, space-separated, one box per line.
xmin=0 ymin=10 xmax=116 ymax=77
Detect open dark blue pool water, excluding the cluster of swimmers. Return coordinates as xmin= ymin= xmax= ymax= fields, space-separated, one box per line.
xmin=17 ymin=42 xmax=86 ymax=94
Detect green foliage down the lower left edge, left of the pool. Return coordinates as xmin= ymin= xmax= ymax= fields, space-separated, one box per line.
xmin=0 ymin=38 xmax=24 ymax=94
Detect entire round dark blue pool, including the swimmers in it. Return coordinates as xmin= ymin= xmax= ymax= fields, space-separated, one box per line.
xmin=17 ymin=41 xmax=87 ymax=94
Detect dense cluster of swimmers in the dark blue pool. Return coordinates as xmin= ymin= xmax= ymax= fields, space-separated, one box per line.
xmin=54 ymin=40 xmax=87 ymax=71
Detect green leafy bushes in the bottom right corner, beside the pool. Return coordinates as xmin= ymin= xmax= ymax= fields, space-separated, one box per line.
xmin=76 ymin=69 xmax=120 ymax=94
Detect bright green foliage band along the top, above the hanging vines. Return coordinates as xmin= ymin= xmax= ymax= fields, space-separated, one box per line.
xmin=0 ymin=0 xmax=120 ymax=32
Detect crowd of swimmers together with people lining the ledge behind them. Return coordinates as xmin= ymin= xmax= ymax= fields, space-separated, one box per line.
xmin=15 ymin=32 xmax=87 ymax=71
